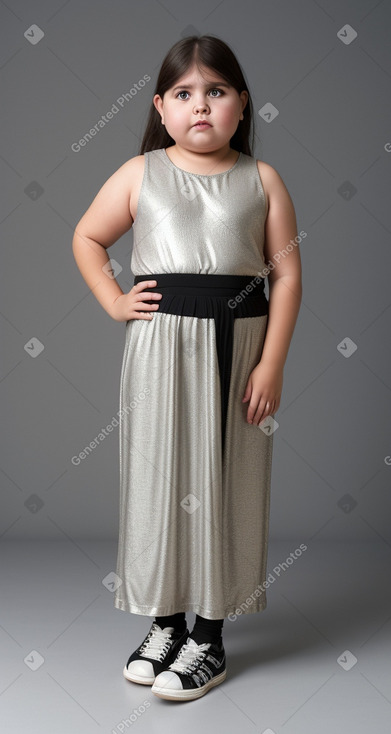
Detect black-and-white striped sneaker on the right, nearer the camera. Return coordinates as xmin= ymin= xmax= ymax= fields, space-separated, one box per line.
xmin=151 ymin=637 xmax=227 ymax=701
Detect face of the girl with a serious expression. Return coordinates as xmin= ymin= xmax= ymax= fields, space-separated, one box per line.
xmin=153 ymin=66 xmax=248 ymax=152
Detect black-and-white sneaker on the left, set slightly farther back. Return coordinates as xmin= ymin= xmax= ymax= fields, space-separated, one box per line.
xmin=123 ymin=622 xmax=189 ymax=686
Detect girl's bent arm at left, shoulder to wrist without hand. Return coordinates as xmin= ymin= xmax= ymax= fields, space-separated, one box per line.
xmin=72 ymin=158 xmax=137 ymax=315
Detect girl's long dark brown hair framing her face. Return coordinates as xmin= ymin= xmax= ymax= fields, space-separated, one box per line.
xmin=139 ymin=35 xmax=254 ymax=156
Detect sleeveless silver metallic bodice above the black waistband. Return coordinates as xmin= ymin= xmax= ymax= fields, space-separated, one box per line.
xmin=130 ymin=148 xmax=267 ymax=275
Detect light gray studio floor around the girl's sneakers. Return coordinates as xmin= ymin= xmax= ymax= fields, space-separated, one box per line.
xmin=0 ymin=539 xmax=391 ymax=734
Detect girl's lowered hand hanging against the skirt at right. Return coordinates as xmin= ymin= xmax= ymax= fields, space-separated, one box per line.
xmin=242 ymin=359 xmax=284 ymax=426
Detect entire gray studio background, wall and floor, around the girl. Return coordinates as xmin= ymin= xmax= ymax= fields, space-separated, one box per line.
xmin=0 ymin=0 xmax=391 ymax=734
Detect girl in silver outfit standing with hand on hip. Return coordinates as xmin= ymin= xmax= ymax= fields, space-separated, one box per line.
xmin=73 ymin=36 xmax=302 ymax=701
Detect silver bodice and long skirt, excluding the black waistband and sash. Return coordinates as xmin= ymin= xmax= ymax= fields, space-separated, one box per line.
xmin=114 ymin=148 xmax=273 ymax=619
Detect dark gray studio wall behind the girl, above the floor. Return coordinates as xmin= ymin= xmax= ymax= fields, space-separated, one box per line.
xmin=0 ymin=0 xmax=391 ymax=551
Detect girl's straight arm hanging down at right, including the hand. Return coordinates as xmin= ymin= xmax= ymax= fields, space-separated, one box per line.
xmin=242 ymin=163 xmax=302 ymax=425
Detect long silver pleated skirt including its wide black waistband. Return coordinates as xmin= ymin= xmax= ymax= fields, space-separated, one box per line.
xmin=114 ymin=273 xmax=273 ymax=619
